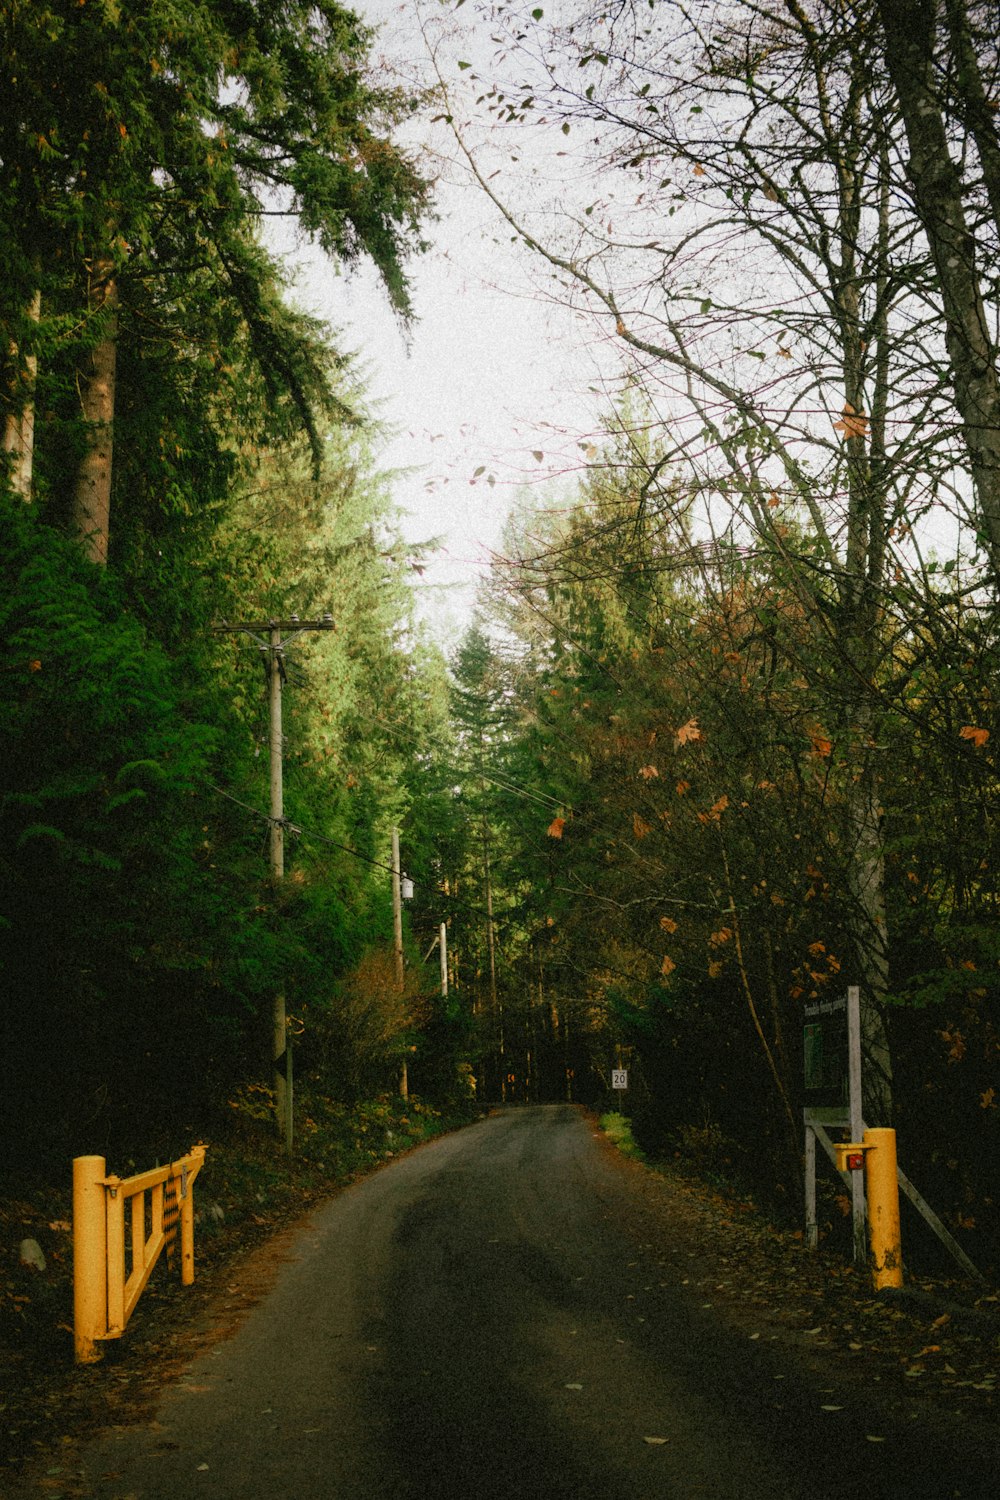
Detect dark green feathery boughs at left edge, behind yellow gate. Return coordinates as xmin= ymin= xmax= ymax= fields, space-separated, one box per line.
xmin=0 ymin=503 xmax=252 ymax=1152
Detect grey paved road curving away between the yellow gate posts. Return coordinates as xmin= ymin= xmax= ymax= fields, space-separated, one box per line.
xmin=76 ymin=1106 xmax=1000 ymax=1500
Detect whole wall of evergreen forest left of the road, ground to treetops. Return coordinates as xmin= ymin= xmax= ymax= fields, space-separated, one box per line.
xmin=0 ymin=0 xmax=458 ymax=1154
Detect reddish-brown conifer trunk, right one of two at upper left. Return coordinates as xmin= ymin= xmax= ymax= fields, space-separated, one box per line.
xmin=73 ymin=261 xmax=118 ymax=567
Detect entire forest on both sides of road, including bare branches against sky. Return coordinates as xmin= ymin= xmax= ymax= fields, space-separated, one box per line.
xmin=0 ymin=0 xmax=1000 ymax=1266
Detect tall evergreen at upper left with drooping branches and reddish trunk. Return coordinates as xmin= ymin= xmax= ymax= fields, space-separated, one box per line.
xmin=0 ymin=0 xmax=426 ymax=563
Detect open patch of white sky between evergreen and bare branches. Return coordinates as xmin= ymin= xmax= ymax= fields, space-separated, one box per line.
xmin=274 ymin=0 xmax=610 ymax=645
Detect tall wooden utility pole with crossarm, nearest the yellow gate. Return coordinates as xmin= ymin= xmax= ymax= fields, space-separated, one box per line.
xmin=211 ymin=615 xmax=336 ymax=1157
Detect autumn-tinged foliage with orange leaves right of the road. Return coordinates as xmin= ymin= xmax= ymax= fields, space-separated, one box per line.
xmin=446 ymin=408 xmax=1000 ymax=1259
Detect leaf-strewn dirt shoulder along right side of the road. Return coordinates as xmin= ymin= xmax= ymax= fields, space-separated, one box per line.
xmin=595 ymin=1130 xmax=1000 ymax=1443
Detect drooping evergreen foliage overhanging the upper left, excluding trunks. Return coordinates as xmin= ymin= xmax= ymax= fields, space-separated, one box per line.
xmin=0 ymin=0 xmax=427 ymax=540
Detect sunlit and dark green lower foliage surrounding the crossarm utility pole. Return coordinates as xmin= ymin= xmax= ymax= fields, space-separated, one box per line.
xmin=0 ymin=381 xmax=462 ymax=1155
